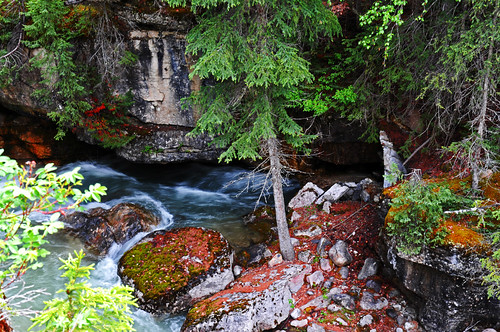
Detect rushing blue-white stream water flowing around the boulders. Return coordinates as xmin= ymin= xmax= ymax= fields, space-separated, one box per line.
xmin=10 ymin=161 xmax=298 ymax=332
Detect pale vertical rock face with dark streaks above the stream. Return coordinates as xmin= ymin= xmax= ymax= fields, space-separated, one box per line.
xmin=120 ymin=29 xmax=200 ymax=127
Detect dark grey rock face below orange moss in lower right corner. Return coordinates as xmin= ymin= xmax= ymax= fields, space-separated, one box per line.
xmin=380 ymin=240 xmax=500 ymax=332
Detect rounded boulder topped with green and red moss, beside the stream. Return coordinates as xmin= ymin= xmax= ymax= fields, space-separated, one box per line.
xmin=118 ymin=227 xmax=234 ymax=314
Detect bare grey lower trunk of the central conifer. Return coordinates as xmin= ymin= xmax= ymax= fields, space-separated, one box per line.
xmin=267 ymin=138 xmax=295 ymax=261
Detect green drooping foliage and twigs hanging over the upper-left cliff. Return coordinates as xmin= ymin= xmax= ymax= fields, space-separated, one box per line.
xmin=0 ymin=0 xmax=133 ymax=147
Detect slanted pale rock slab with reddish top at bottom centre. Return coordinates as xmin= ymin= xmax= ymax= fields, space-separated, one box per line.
xmin=181 ymin=264 xmax=307 ymax=332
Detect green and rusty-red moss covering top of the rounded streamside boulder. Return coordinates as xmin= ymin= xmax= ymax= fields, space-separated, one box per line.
xmin=120 ymin=227 xmax=230 ymax=300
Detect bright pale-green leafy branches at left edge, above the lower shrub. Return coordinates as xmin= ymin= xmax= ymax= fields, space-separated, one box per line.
xmin=0 ymin=150 xmax=106 ymax=294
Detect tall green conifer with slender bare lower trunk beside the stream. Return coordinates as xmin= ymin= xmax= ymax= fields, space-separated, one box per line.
xmin=164 ymin=0 xmax=340 ymax=260
